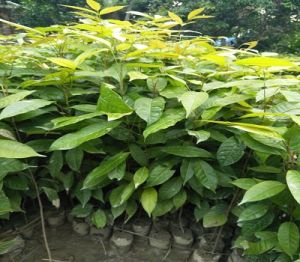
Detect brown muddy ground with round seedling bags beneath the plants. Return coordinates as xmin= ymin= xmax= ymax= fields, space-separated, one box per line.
xmin=0 ymin=211 xmax=240 ymax=262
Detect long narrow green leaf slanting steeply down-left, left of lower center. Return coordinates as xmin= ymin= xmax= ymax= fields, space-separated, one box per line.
xmin=83 ymin=152 xmax=129 ymax=188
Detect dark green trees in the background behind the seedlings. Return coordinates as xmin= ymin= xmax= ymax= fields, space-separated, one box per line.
xmin=9 ymin=0 xmax=300 ymax=53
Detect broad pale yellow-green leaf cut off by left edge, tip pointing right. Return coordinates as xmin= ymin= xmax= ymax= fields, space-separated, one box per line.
xmin=0 ymin=139 xmax=42 ymax=158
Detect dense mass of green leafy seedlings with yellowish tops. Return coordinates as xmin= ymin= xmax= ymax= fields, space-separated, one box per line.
xmin=0 ymin=0 xmax=300 ymax=261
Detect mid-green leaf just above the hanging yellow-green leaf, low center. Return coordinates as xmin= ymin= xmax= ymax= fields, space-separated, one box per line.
xmin=146 ymin=165 xmax=175 ymax=187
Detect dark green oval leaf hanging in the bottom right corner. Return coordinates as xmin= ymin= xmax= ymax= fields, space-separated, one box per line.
xmin=278 ymin=222 xmax=300 ymax=256
